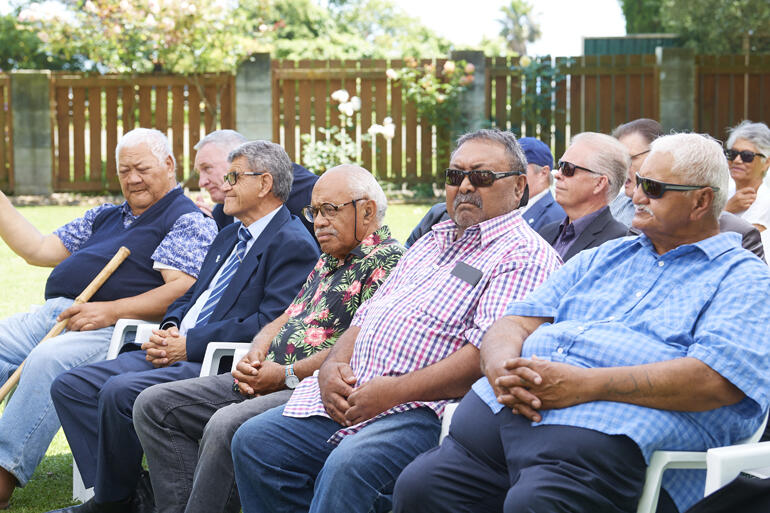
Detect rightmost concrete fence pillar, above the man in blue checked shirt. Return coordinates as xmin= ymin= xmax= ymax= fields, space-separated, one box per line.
xmin=655 ymin=46 xmax=695 ymax=133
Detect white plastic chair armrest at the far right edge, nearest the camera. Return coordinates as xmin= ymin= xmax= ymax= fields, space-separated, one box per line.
xmin=705 ymin=442 xmax=770 ymax=495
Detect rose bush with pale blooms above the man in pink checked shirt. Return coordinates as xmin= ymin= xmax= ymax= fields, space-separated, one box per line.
xmin=386 ymin=57 xmax=475 ymax=131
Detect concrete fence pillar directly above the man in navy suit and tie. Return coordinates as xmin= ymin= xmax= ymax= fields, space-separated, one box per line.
xmin=235 ymin=53 xmax=273 ymax=141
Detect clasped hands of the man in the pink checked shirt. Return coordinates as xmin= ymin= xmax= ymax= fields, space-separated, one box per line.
xmin=318 ymin=361 xmax=402 ymax=426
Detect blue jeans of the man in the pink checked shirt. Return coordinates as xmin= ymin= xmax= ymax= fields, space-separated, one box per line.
xmin=232 ymin=406 xmax=441 ymax=513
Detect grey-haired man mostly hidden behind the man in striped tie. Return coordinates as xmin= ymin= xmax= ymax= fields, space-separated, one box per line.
xmin=195 ymin=130 xmax=318 ymax=234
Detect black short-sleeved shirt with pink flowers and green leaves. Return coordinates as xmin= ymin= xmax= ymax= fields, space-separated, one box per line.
xmin=267 ymin=226 xmax=405 ymax=365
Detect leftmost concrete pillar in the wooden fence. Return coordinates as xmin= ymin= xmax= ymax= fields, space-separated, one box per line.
xmin=11 ymin=70 xmax=53 ymax=195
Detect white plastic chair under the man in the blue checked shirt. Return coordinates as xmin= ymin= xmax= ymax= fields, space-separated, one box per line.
xmin=439 ymin=403 xmax=770 ymax=513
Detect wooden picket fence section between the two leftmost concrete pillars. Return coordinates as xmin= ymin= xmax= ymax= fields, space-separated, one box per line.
xmin=51 ymin=73 xmax=235 ymax=192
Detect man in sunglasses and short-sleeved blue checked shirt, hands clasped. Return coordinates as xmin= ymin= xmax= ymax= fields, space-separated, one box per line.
xmin=394 ymin=134 xmax=770 ymax=513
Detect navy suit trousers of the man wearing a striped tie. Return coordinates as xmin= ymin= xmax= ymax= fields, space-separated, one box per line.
xmin=51 ymin=351 xmax=201 ymax=502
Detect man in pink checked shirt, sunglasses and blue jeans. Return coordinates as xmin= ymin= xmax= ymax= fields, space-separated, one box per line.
xmin=232 ymin=130 xmax=560 ymax=513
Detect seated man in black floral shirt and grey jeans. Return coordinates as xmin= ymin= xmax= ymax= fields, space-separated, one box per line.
xmin=133 ymin=166 xmax=404 ymax=513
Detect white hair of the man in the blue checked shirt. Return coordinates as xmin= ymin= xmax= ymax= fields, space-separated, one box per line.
xmin=648 ymin=134 xmax=730 ymax=219
